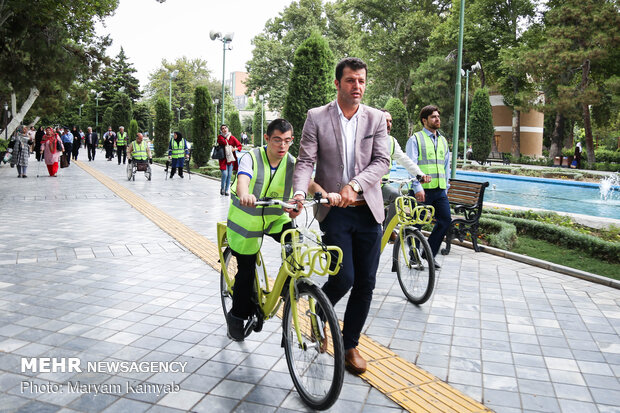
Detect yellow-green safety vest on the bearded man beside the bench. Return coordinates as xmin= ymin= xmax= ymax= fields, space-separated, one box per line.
xmin=414 ymin=131 xmax=449 ymax=189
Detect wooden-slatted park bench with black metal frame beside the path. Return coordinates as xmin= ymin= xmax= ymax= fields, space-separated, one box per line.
xmin=441 ymin=179 xmax=489 ymax=255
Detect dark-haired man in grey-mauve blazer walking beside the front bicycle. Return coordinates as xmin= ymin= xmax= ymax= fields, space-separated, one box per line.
xmin=293 ymin=58 xmax=390 ymax=374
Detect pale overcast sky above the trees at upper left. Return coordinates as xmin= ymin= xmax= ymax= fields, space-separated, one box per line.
xmin=97 ymin=0 xmax=292 ymax=88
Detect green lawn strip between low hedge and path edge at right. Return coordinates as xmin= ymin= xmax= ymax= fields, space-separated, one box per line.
xmin=512 ymin=235 xmax=620 ymax=280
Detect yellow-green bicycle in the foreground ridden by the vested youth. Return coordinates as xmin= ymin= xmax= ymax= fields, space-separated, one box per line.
xmin=217 ymin=196 xmax=344 ymax=410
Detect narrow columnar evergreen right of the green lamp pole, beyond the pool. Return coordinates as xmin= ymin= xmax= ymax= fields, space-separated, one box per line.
xmin=467 ymin=88 xmax=495 ymax=163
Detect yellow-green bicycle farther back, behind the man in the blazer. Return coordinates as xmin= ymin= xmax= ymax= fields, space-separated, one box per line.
xmin=381 ymin=179 xmax=435 ymax=305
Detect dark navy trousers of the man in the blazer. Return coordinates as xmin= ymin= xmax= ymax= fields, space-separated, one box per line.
xmin=320 ymin=205 xmax=381 ymax=350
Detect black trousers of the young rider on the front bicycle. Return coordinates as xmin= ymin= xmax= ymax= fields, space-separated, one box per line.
xmin=230 ymin=222 xmax=292 ymax=319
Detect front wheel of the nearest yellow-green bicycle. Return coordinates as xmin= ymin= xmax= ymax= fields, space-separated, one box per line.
xmin=282 ymin=282 xmax=344 ymax=410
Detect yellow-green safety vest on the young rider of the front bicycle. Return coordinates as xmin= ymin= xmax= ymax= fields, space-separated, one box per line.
xmin=226 ymin=147 xmax=295 ymax=255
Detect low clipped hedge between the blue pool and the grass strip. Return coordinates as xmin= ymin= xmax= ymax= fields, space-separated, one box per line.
xmin=485 ymin=211 xmax=620 ymax=263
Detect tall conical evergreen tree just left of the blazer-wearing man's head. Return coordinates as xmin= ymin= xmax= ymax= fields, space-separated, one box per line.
xmin=282 ymin=33 xmax=334 ymax=156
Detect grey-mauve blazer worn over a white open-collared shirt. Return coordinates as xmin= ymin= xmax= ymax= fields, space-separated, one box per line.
xmin=293 ymin=100 xmax=390 ymax=223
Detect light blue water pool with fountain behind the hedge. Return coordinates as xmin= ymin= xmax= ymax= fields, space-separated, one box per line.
xmin=391 ymin=166 xmax=620 ymax=219
